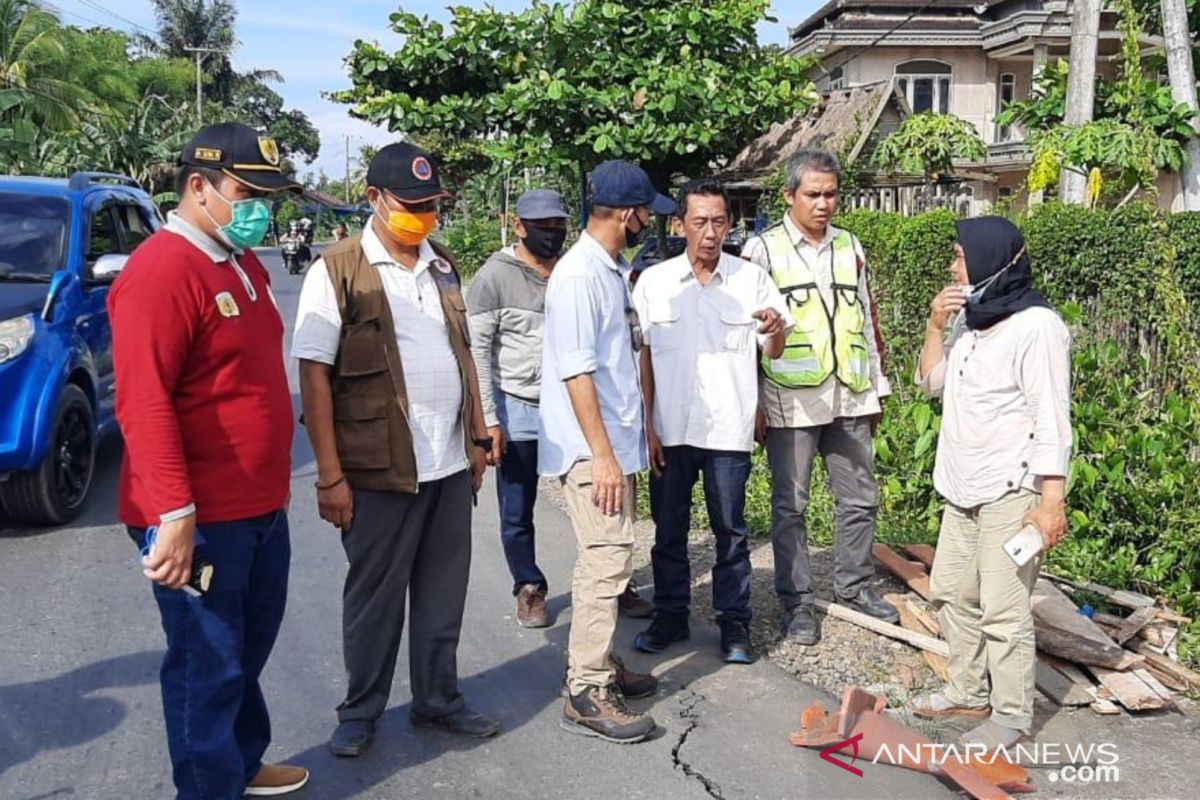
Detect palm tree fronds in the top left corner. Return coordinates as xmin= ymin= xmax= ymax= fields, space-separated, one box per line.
xmin=0 ymin=0 xmax=86 ymax=132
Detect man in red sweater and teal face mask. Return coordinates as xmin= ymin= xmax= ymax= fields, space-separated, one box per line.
xmin=108 ymin=124 xmax=308 ymax=800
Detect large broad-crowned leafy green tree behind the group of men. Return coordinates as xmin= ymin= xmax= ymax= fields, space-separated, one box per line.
xmin=331 ymin=0 xmax=816 ymax=194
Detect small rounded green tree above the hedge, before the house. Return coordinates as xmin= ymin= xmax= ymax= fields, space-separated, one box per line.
xmin=875 ymin=112 xmax=988 ymax=184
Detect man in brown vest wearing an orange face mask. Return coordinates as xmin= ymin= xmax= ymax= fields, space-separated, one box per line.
xmin=292 ymin=143 xmax=499 ymax=757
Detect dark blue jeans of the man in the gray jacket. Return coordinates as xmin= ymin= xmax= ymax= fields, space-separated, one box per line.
xmin=496 ymin=439 xmax=546 ymax=595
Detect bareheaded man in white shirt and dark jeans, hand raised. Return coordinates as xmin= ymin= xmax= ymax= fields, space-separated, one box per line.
xmin=634 ymin=180 xmax=792 ymax=663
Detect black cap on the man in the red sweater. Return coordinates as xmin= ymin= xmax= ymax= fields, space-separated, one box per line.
xmin=178 ymin=122 xmax=304 ymax=193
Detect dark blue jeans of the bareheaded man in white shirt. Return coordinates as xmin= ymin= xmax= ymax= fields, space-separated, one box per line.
xmin=650 ymin=446 xmax=750 ymax=622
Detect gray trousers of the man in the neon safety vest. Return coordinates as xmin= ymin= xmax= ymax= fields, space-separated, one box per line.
xmin=767 ymin=416 xmax=878 ymax=608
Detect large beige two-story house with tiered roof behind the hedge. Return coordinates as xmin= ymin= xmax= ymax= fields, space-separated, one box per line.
xmin=731 ymin=0 xmax=1171 ymax=213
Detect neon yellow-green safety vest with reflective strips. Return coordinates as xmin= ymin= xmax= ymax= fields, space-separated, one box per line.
xmin=762 ymin=224 xmax=871 ymax=393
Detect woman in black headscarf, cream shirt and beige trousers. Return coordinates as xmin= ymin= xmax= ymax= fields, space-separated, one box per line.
xmin=910 ymin=217 xmax=1072 ymax=748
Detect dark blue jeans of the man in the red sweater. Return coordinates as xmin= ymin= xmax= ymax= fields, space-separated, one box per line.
xmin=130 ymin=511 xmax=292 ymax=800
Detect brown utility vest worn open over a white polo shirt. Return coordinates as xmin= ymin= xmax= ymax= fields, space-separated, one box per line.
xmin=322 ymin=236 xmax=474 ymax=493
